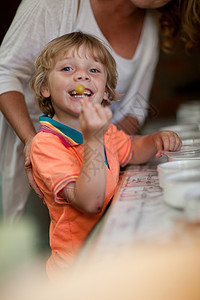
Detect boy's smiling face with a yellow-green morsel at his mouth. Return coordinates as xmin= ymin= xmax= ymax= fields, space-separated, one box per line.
xmin=42 ymin=46 xmax=107 ymax=123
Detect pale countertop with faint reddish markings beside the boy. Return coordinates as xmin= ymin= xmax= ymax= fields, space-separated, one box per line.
xmin=76 ymin=159 xmax=200 ymax=264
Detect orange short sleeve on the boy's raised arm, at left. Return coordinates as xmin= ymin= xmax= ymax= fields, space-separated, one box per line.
xmin=31 ymin=133 xmax=82 ymax=203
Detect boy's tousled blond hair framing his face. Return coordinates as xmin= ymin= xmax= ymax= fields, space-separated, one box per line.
xmin=31 ymin=31 xmax=118 ymax=117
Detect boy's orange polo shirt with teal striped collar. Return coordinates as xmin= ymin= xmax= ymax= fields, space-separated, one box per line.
xmin=31 ymin=116 xmax=132 ymax=277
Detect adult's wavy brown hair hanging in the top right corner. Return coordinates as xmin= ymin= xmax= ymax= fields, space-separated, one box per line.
xmin=158 ymin=0 xmax=200 ymax=52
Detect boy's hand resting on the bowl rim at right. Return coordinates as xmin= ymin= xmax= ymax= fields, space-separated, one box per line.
xmin=152 ymin=131 xmax=182 ymax=158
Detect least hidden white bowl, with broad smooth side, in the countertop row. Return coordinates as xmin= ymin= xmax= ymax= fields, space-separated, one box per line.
xmin=164 ymin=170 xmax=200 ymax=209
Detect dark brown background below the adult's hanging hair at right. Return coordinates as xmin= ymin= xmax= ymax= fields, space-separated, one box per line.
xmin=147 ymin=42 xmax=200 ymax=122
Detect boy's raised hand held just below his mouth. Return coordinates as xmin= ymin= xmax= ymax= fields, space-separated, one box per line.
xmin=79 ymin=99 xmax=112 ymax=140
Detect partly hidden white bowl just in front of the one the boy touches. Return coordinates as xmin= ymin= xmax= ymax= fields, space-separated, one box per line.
xmin=157 ymin=159 xmax=200 ymax=188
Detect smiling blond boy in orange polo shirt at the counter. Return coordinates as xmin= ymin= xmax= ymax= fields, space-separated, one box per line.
xmin=31 ymin=32 xmax=182 ymax=277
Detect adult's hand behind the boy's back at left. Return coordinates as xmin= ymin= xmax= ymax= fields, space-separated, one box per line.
xmin=24 ymin=138 xmax=44 ymax=199
